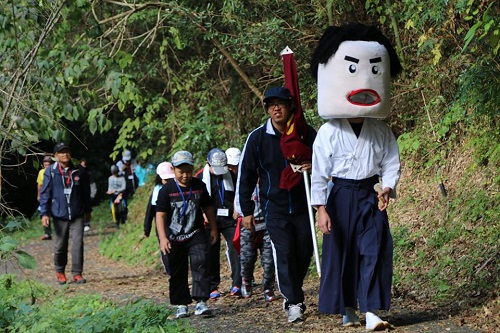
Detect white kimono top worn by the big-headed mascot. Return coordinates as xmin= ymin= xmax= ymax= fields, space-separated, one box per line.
xmin=311 ymin=118 xmax=400 ymax=206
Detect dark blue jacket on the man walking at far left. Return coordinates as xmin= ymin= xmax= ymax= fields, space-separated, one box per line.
xmin=40 ymin=162 xmax=92 ymax=221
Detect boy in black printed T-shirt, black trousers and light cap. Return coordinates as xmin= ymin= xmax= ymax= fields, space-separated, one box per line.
xmin=156 ymin=151 xmax=218 ymax=318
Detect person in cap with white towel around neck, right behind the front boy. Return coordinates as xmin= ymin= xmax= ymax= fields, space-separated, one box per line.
xmin=199 ymin=148 xmax=241 ymax=299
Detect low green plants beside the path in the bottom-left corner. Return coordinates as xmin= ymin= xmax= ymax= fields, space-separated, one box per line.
xmin=0 ymin=274 xmax=191 ymax=333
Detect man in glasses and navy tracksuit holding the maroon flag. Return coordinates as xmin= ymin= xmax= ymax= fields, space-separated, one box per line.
xmin=236 ymin=87 xmax=316 ymax=322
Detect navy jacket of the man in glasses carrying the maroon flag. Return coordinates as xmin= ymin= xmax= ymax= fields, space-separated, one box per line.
xmin=236 ymin=119 xmax=316 ymax=216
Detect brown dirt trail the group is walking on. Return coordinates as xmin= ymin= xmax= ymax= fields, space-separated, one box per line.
xmin=11 ymin=228 xmax=496 ymax=333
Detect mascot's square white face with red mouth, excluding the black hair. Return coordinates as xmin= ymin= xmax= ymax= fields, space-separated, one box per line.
xmin=318 ymin=41 xmax=391 ymax=119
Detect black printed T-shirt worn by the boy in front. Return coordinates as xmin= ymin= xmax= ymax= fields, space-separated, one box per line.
xmin=156 ymin=177 xmax=212 ymax=242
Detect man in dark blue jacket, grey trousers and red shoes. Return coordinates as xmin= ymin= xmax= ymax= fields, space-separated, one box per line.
xmin=40 ymin=143 xmax=92 ymax=284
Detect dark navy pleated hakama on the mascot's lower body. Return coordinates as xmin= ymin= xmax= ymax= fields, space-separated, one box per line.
xmin=319 ymin=176 xmax=393 ymax=314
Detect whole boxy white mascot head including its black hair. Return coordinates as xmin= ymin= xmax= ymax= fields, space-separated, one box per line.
xmin=311 ymin=24 xmax=402 ymax=119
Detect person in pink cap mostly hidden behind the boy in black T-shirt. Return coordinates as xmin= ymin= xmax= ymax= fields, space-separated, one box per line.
xmin=144 ymin=162 xmax=175 ymax=275
